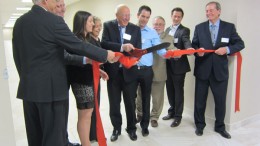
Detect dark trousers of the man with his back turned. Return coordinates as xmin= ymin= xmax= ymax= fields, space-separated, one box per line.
xmin=23 ymin=100 xmax=68 ymax=146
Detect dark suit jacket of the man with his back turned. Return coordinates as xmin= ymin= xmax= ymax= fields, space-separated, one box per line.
xmin=13 ymin=5 xmax=107 ymax=102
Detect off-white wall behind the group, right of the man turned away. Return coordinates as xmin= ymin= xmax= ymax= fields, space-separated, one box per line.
xmin=65 ymin=0 xmax=260 ymax=130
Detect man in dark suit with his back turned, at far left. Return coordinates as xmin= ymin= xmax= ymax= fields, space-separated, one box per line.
xmin=13 ymin=0 xmax=115 ymax=146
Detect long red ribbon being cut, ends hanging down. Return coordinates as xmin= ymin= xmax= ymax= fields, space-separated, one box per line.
xmin=92 ymin=49 xmax=242 ymax=146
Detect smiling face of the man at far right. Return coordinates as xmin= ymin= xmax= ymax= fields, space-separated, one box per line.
xmin=206 ymin=3 xmax=221 ymax=24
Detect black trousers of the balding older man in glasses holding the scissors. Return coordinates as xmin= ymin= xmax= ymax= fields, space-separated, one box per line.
xmin=107 ymin=69 xmax=137 ymax=132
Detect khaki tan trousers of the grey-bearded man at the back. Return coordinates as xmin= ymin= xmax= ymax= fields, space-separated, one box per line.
xmin=136 ymin=81 xmax=165 ymax=121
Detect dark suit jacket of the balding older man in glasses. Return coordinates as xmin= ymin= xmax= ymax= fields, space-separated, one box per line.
xmin=101 ymin=20 xmax=142 ymax=82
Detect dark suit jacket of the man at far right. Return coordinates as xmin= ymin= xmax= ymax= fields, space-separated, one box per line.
xmin=192 ymin=20 xmax=245 ymax=81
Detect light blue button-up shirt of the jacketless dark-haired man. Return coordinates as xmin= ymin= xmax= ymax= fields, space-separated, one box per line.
xmin=137 ymin=26 xmax=166 ymax=66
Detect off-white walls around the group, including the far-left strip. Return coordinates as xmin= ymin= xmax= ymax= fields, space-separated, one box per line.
xmin=0 ymin=0 xmax=260 ymax=146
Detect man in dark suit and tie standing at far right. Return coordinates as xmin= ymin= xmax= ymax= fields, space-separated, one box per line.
xmin=192 ymin=2 xmax=244 ymax=139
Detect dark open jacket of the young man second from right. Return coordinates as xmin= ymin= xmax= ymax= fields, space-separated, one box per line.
xmin=165 ymin=24 xmax=191 ymax=74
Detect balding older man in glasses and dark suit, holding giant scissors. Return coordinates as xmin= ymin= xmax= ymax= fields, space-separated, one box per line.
xmin=101 ymin=5 xmax=141 ymax=141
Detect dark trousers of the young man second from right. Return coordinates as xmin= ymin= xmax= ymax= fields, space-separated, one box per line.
xmin=166 ymin=69 xmax=186 ymax=120
